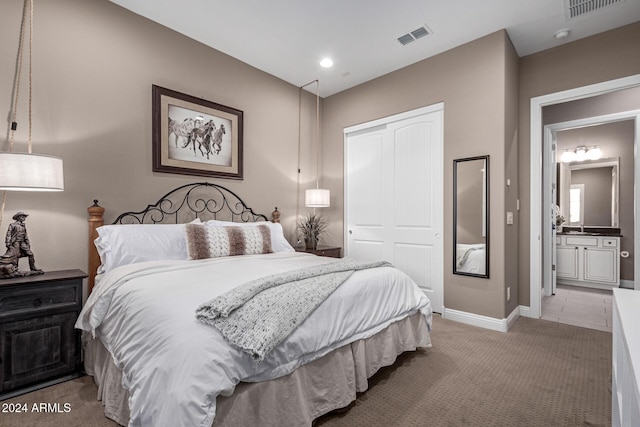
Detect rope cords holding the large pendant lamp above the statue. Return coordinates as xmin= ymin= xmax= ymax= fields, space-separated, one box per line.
xmin=0 ymin=0 xmax=33 ymax=231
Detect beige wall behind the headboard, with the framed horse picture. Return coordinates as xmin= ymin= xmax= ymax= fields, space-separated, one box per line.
xmin=0 ymin=0 xmax=315 ymax=294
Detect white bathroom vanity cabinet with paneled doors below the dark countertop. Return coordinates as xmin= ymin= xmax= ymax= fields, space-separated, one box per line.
xmin=556 ymin=234 xmax=620 ymax=289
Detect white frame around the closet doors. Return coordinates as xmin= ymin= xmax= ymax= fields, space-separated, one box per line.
xmin=342 ymin=102 xmax=445 ymax=312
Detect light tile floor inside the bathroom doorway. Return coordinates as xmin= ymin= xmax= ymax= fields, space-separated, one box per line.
xmin=542 ymin=285 xmax=613 ymax=332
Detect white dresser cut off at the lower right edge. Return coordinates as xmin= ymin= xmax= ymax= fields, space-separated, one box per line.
xmin=611 ymin=289 xmax=640 ymax=427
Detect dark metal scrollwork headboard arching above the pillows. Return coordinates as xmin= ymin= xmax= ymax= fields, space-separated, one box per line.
xmin=113 ymin=182 xmax=267 ymax=224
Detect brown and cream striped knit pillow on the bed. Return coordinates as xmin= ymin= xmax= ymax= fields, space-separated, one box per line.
xmin=185 ymin=224 xmax=273 ymax=259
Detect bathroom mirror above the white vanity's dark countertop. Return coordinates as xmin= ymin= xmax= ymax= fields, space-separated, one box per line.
xmin=558 ymin=158 xmax=620 ymax=227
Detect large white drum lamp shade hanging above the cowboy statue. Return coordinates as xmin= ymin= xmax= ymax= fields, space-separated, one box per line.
xmin=0 ymin=152 xmax=64 ymax=191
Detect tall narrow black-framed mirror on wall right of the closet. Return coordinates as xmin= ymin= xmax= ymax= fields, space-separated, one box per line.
xmin=453 ymin=156 xmax=489 ymax=278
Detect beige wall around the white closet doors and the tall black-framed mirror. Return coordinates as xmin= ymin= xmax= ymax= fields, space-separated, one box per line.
xmin=324 ymin=31 xmax=515 ymax=319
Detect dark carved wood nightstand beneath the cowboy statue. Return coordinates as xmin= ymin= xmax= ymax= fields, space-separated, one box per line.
xmin=0 ymin=270 xmax=87 ymax=400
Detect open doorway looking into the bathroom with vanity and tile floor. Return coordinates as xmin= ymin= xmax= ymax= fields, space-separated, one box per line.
xmin=541 ymin=116 xmax=640 ymax=332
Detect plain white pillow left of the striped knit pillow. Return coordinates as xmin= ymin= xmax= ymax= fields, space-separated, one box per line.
xmin=94 ymin=224 xmax=189 ymax=274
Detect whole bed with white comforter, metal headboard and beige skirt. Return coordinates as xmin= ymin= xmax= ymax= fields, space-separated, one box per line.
xmin=76 ymin=183 xmax=431 ymax=427
